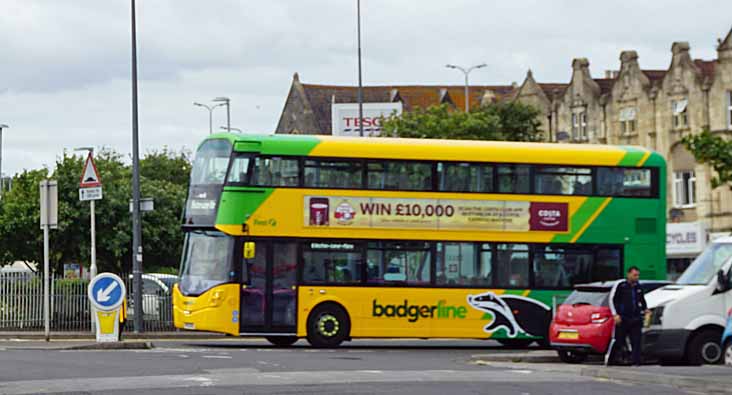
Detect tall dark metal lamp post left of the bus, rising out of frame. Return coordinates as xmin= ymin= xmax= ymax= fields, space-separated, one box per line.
xmin=131 ymin=0 xmax=143 ymax=333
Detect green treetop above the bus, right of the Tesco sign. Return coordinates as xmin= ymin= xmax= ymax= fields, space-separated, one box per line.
xmin=382 ymin=101 xmax=543 ymax=141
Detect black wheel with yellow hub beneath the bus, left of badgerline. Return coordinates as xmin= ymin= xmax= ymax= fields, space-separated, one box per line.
xmin=307 ymin=303 xmax=351 ymax=348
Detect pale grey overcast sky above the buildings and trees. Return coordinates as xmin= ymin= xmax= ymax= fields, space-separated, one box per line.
xmin=0 ymin=0 xmax=732 ymax=174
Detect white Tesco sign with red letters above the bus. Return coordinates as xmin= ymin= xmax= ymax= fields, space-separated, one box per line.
xmin=331 ymin=102 xmax=402 ymax=137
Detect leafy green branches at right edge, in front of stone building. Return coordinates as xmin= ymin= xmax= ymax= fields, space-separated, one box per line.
xmin=681 ymin=129 xmax=732 ymax=188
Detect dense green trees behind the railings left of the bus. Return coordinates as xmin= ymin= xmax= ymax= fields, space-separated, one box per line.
xmin=0 ymin=149 xmax=191 ymax=272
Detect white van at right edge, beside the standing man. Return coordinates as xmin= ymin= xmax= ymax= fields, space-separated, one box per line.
xmin=643 ymin=237 xmax=732 ymax=365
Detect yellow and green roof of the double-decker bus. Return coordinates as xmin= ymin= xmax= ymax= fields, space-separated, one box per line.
xmin=202 ymin=133 xmax=665 ymax=167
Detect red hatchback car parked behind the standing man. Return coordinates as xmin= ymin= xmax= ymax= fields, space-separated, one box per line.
xmin=549 ymin=281 xmax=669 ymax=363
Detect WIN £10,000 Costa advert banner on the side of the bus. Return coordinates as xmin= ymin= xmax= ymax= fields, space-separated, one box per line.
xmin=303 ymin=196 xmax=569 ymax=232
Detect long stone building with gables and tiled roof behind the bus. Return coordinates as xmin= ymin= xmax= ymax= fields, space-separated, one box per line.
xmin=276 ymin=30 xmax=732 ymax=276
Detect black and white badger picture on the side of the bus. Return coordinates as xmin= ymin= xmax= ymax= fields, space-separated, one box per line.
xmin=468 ymin=292 xmax=551 ymax=338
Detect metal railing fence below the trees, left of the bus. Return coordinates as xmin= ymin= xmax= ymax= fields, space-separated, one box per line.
xmin=0 ymin=272 xmax=176 ymax=332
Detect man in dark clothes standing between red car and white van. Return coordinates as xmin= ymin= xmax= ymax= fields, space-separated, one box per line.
xmin=610 ymin=266 xmax=648 ymax=366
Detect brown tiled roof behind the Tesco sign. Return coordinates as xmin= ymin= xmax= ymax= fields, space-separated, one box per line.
xmin=301 ymin=84 xmax=516 ymax=134
